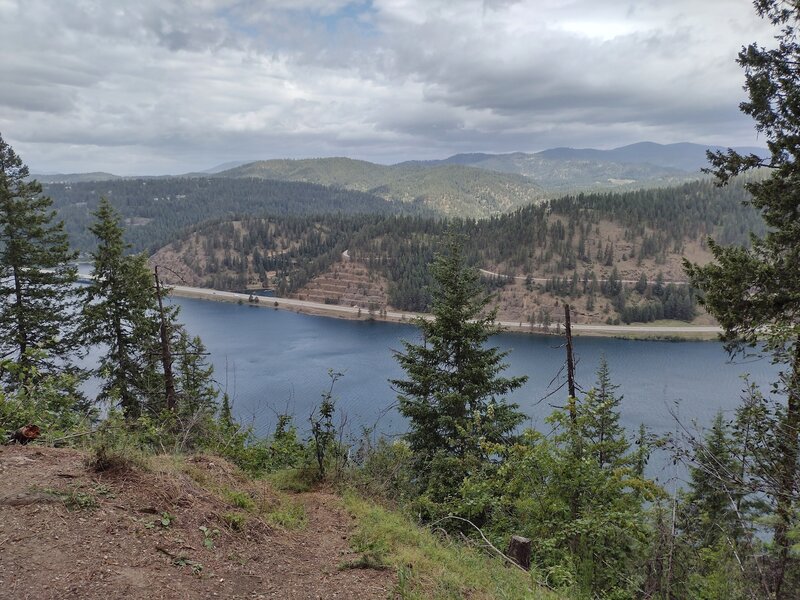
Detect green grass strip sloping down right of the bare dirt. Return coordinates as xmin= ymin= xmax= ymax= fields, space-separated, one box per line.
xmin=344 ymin=495 xmax=565 ymax=600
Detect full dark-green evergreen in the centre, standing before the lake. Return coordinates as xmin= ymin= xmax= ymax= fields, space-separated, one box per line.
xmin=391 ymin=234 xmax=526 ymax=501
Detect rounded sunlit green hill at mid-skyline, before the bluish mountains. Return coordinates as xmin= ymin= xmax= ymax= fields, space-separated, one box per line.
xmin=217 ymin=158 xmax=544 ymax=217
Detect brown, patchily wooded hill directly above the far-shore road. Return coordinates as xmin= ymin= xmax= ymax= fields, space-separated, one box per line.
xmin=156 ymin=177 xmax=763 ymax=321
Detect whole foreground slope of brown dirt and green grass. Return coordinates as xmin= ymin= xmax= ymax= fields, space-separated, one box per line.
xmin=0 ymin=446 xmax=556 ymax=600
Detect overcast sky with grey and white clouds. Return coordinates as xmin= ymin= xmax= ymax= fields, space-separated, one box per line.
xmin=0 ymin=0 xmax=775 ymax=175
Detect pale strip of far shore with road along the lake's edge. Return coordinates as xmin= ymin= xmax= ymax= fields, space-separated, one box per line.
xmin=170 ymin=285 xmax=722 ymax=341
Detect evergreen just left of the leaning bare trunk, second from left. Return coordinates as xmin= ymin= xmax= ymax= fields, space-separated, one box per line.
xmin=82 ymin=199 xmax=159 ymax=417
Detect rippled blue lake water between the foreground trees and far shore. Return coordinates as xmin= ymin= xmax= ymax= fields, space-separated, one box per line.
xmin=174 ymin=298 xmax=777 ymax=482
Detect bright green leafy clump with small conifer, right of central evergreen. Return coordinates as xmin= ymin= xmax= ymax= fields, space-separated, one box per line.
xmin=449 ymin=360 xmax=661 ymax=597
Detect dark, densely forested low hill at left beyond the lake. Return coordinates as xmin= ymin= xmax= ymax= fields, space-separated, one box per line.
xmin=43 ymin=177 xmax=430 ymax=253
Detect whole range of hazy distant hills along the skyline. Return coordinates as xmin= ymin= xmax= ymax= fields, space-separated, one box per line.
xmin=32 ymin=142 xmax=767 ymax=218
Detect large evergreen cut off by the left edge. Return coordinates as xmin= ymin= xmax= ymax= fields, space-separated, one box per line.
xmin=0 ymin=132 xmax=78 ymax=380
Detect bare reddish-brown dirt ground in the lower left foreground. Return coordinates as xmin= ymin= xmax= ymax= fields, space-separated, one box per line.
xmin=0 ymin=446 xmax=394 ymax=600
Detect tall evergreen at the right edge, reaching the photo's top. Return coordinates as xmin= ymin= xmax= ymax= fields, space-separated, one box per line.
xmin=686 ymin=0 xmax=800 ymax=599
